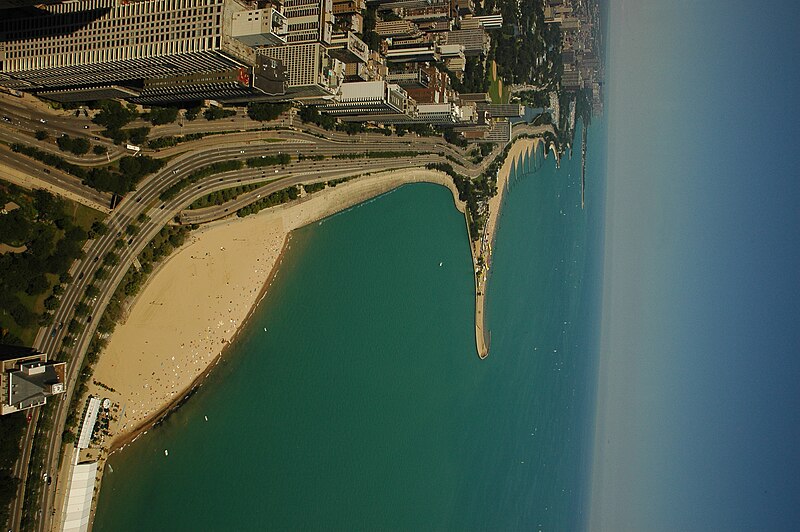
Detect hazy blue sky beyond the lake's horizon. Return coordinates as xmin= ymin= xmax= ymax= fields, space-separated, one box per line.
xmin=589 ymin=0 xmax=800 ymax=531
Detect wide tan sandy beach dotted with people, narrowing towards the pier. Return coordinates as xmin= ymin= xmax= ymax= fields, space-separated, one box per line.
xmin=89 ymin=170 xmax=464 ymax=444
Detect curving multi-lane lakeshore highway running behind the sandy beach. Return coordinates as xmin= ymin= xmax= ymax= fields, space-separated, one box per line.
xmin=1 ymin=95 xmax=552 ymax=531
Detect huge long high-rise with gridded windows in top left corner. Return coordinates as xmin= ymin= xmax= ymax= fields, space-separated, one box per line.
xmin=0 ymin=0 xmax=255 ymax=89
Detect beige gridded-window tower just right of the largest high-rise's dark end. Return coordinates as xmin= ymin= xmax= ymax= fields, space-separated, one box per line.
xmin=258 ymin=42 xmax=345 ymax=103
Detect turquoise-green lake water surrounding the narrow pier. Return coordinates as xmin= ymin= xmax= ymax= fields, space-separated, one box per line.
xmin=94 ymin=122 xmax=603 ymax=531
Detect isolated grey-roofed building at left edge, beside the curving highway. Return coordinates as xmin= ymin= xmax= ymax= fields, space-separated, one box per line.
xmin=0 ymin=345 xmax=67 ymax=415
